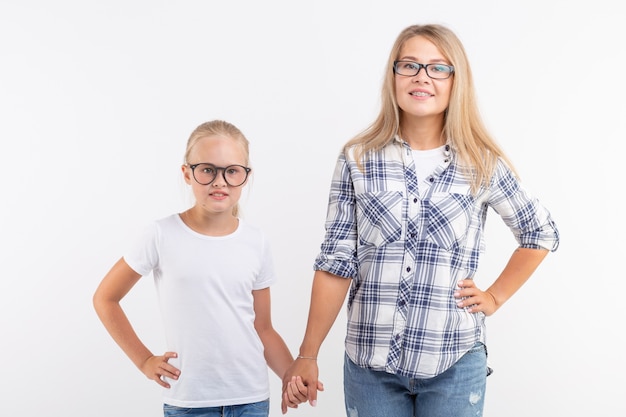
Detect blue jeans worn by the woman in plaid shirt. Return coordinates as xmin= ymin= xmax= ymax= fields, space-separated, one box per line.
xmin=343 ymin=343 xmax=488 ymax=417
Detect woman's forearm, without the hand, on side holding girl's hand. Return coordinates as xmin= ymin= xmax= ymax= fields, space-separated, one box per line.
xmin=299 ymin=271 xmax=352 ymax=358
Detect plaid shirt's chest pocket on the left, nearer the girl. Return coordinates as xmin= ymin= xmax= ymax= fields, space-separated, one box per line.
xmin=356 ymin=191 xmax=404 ymax=246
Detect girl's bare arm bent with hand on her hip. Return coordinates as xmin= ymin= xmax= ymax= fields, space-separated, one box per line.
xmin=93 ymin=258 xmax=180 ymax=388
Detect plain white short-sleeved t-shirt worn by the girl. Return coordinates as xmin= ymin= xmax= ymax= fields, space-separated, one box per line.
xmin=124 ymin=214 xmax=275 ymax=408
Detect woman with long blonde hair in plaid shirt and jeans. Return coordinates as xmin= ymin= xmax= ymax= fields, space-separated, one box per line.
xmin=285 ymin=25 xmax=559 ymax=417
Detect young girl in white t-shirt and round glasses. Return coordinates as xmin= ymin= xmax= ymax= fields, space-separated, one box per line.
xmin=93 ymin=120 xmax=306 ymax=416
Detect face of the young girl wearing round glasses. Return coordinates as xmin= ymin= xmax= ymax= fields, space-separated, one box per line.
xmin=183 ymin=135 xmax=247 ymax=215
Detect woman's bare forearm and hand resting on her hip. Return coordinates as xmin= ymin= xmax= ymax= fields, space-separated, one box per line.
xmin=455 ymin=248 xmax=548 ymax=316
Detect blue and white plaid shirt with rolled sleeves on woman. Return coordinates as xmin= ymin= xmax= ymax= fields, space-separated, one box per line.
xmin=314 ymin=138 xmax=559 ymax=378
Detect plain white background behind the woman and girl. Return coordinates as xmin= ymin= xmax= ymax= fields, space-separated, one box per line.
xmin=0 ymin=0 xmax=626 ymax=417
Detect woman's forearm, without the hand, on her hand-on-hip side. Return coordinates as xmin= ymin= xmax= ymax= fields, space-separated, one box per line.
xmin=486 ymin=248 xmax=548 ymax=308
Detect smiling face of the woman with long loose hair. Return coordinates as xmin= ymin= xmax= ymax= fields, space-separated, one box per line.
xmin=395 ymin=36 xmax=454 ymax=121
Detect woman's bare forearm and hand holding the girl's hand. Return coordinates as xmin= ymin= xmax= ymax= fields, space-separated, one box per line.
xmin=282 ymin=271 xmax=352 ymax=414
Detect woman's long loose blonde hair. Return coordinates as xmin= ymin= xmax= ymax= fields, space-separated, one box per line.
xmin=345 ymin=24 xmax=517 ymax=192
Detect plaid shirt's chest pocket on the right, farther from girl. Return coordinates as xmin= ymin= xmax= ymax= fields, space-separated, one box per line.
xmin=426 ymin=193 xmax=474 ymax=250
